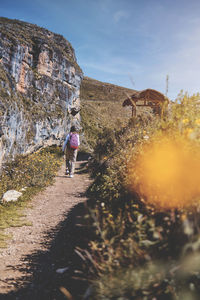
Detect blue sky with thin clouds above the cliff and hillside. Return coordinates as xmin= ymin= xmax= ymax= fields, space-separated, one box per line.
xmin=0 ymin=0 xmax=200 ymax=100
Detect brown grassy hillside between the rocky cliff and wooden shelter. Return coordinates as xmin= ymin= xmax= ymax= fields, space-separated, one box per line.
xmin=80 ymin=77 xmax=152 ymax=150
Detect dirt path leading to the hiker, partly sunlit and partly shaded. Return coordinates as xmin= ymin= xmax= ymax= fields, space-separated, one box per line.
xmin=0 ymin=161 xmax=91 ymax=300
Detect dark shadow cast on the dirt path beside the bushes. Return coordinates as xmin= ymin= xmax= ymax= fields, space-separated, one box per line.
xmin=0 ymin=152 xmax=92 ymax=300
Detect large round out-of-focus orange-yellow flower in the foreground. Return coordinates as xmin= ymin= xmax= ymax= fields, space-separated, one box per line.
xmin=128 ymin=135 xmax=200 ymax=209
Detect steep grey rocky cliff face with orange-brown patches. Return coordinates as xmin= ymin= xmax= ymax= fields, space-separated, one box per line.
xmin=0 ymin=18 xmax=83 ymax=167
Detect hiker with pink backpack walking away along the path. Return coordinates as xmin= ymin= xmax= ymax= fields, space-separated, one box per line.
xmin=63 ymin=126 xmax=80 ymax=178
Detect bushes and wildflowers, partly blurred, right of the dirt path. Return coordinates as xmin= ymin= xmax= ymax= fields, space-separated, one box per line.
xmin=79 ymin=92 xmax=200 ymax=300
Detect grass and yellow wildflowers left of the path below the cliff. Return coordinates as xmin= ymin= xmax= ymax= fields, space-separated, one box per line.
xmin=0 ymin=147 xmax=62 ymax=247
